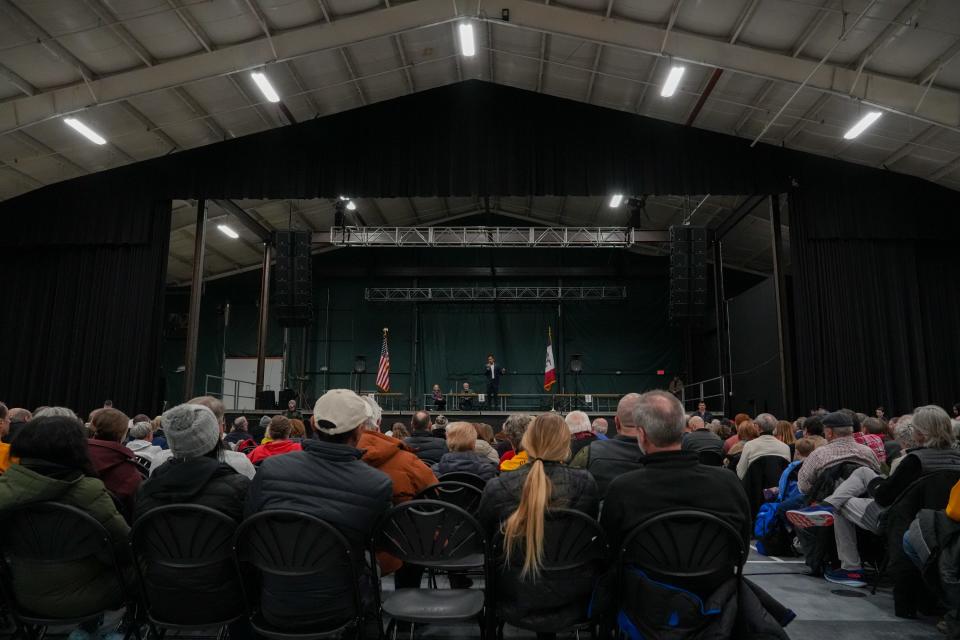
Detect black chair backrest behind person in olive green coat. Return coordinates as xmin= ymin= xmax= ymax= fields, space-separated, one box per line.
xmin=0 ymin=502 xmax=129 ymax=622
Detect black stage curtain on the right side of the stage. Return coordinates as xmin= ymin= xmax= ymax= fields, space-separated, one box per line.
xmin=790 ymin=167 xmax=960 ymax=415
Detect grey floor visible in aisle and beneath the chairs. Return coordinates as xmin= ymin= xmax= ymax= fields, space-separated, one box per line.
xmin=16 ymin=551 xmax=944 ymax=640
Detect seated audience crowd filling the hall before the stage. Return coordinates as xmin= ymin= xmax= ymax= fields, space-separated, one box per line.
xmin=0 ymin=389 xmax=960 ymax=640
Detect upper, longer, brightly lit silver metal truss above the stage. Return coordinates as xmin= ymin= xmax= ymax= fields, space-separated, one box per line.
xmin=329 ymin=227 xmax=667 ymax=248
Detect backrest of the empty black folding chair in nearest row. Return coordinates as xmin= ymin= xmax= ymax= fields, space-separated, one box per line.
xmin=374 ymin=500 xmax=488 ymax=564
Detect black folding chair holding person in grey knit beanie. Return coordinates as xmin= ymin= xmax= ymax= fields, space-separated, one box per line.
xmin=130 ymin=504 xmax=244 ymax=638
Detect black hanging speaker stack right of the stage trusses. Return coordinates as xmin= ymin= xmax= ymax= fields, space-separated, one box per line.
xmin=670 ymin=226 xmax=707 ymax=320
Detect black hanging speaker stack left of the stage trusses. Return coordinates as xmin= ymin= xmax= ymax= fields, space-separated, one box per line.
xmin=272 ymin=231 xmax=313 ymax=327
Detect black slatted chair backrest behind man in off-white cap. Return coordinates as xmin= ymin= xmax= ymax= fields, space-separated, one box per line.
xmin=234 ymin=509 xmax=362 ymax=632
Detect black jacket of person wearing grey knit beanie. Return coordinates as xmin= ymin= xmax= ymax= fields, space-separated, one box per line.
xmin=134 ymin=458 xmax=250 ymax=623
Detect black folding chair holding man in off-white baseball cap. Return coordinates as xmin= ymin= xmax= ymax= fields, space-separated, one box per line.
xmin=234 ymin=509 xmax=375 ymax=640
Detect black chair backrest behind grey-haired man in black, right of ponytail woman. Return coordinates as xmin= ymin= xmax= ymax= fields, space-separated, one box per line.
xmin=619 ymin=509 xmax=747 ymax=580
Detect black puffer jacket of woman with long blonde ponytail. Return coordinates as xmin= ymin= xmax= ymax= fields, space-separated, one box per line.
xmin=478 ymin=462 xmax=602 ymax=631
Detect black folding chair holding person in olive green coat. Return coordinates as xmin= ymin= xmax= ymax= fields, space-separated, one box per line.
xmin=0 ymin=502 xmax=141 ymax=640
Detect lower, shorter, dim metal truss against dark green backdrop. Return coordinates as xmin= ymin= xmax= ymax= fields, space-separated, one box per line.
xmin=364 ymin=287 xmax=627 ymax=302
